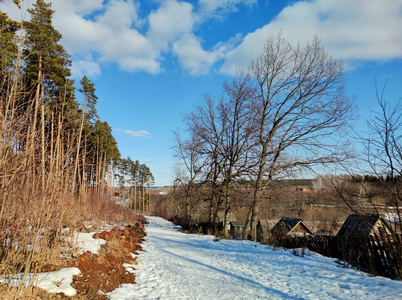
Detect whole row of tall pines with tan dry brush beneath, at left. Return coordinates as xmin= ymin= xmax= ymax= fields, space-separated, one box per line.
xmin=0 ymin=0 xmax=152 ymax=280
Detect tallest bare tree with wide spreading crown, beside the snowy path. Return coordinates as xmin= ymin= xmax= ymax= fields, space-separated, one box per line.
xmin=245 ymin=33 xmax=353 ymax=240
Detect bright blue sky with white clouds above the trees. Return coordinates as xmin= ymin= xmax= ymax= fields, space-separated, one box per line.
xmin=0 ymin=0 xmax=402 ymax=185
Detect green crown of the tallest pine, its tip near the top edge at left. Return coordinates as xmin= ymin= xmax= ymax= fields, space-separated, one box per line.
xmin=23 ymin=0 xmax=77 ymax=115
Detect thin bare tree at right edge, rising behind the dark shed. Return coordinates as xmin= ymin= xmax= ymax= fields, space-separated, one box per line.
xmin=330 ymin=86 xmax=402 ymax=225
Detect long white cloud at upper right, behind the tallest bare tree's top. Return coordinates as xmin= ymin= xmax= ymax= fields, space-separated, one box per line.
xmin=221 ymin=0 xmax=402 ymax=73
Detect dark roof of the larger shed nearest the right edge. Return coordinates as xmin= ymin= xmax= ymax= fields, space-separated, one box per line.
xmin=338 ymin=215 xmax=389 ymax=237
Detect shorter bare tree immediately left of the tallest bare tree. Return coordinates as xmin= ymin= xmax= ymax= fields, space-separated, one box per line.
xmin=175 ymin=74 xmax=255 ymax=231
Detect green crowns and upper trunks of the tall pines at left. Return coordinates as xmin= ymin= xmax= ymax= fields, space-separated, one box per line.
xmin=0 ymin=0 xmax=124 ymax=195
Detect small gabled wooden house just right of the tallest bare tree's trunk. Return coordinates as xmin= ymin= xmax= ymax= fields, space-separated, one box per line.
xmin=271 ymin=217 xmax=313 ymax=239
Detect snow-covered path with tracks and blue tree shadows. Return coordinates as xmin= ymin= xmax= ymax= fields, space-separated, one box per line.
xmin=109 ymin=217 xmax=402 ymax=300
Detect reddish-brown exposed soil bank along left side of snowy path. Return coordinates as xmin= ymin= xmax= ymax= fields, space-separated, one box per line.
xmin=0 ymin=222 xmax=145 ymax=299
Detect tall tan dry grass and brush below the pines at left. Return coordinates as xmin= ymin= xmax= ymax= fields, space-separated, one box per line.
xmin=0 ymin=34 xmax=138 ymax=296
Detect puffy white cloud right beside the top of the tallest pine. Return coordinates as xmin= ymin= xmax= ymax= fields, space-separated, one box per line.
xmin=54 ymin=0 xmax=160 ymax=75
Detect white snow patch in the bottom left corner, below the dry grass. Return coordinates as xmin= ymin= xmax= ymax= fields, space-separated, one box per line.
xmin=0 ymin=268 xmax=81 ymax=296
